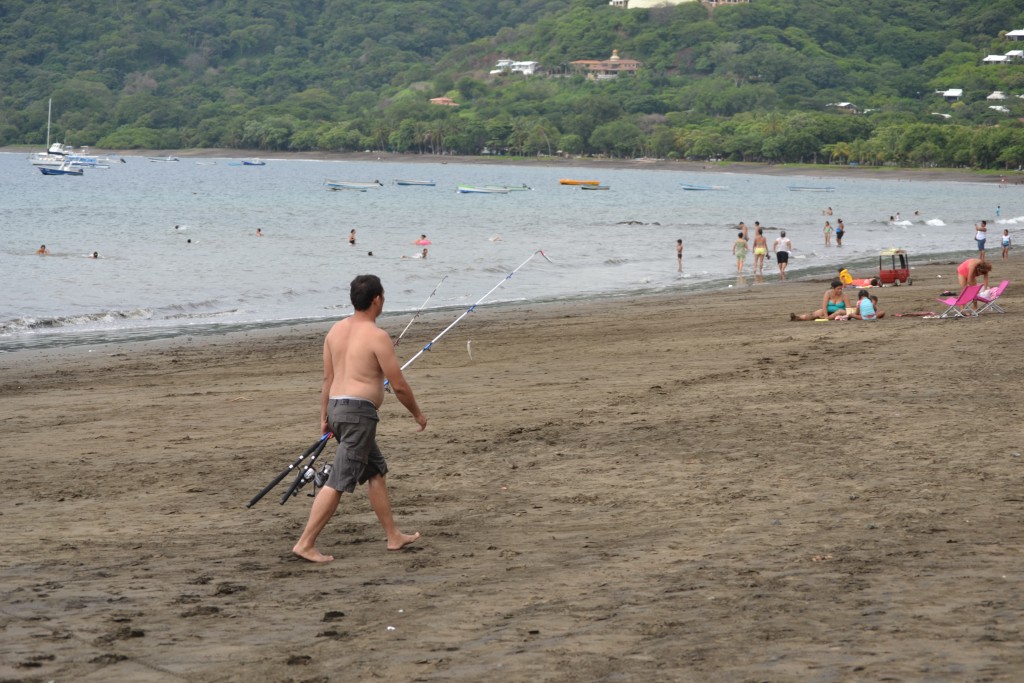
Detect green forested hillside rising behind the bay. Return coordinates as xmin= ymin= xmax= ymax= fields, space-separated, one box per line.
xmin=0 ymin=0 xmax=1024 ymax=168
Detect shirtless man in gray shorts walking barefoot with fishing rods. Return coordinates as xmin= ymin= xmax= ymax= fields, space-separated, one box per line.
xmin=292 ymin=275 xmax=427 ymax=562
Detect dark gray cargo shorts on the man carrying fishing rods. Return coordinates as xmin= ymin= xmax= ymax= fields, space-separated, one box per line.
xmin=327 ymin=398 xmax=387 ymax=494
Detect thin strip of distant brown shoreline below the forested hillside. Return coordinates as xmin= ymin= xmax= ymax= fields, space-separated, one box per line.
xmin=6 ymin=145 xmax=1024 ymax=184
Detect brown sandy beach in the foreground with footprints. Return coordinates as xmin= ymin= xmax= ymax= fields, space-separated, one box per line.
xmin=0 ymin=255 xmax=1024 ymax=683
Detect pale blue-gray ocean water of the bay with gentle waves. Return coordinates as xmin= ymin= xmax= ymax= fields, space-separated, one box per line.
xmin=0 ymin=154 xmax=1024 ymax=352
